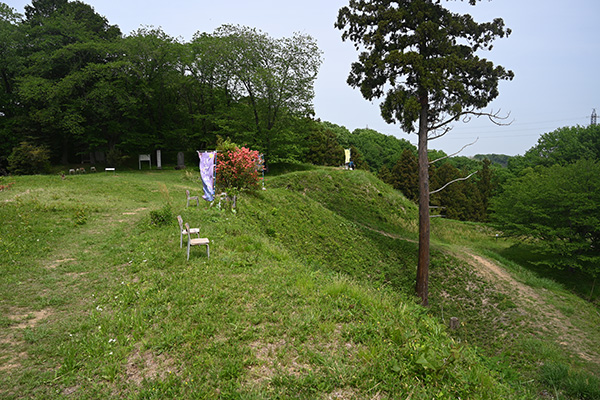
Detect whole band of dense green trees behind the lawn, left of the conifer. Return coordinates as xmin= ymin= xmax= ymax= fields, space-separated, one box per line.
xmin=0 ymin=0 xmax=321 ymax=167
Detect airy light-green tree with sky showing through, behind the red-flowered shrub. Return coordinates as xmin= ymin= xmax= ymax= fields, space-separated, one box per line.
xmin=214 ymin=25 xmax=322 ymax=162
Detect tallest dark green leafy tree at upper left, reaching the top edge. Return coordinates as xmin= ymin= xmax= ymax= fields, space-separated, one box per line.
xmin=17 ymin=0 xmax=121 ymax=164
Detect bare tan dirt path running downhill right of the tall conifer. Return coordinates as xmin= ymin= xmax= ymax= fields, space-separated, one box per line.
xmin=455 ymin=251 xmax=600 ymax=364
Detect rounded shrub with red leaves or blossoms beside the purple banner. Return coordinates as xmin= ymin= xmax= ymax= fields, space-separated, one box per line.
xmin=216 ymin=146 xmax=259 ymax=191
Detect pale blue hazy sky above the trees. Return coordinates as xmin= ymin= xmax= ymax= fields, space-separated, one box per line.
xmin=5 ymin=0 xmax=600 ymax=155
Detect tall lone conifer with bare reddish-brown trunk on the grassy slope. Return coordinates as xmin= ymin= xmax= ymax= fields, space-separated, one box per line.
xmin=335 ymin=0 xmax=513 ymax=305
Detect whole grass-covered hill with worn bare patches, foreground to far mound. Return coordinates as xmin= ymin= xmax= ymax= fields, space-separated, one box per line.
xmin=0 ymin=169 xmax=600 ymax=399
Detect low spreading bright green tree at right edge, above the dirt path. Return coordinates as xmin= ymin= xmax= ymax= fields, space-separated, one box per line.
xmin=493 ymin=160 xmax=600 ymax=276
